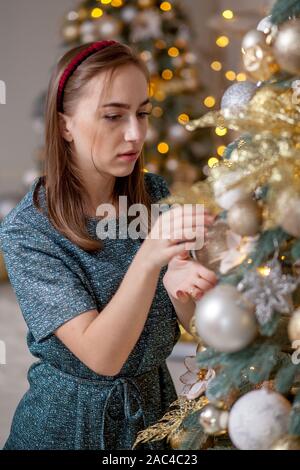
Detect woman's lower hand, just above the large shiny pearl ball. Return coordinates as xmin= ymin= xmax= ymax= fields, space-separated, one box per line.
xmin=163 ymin=251 xmax=217 ymax=303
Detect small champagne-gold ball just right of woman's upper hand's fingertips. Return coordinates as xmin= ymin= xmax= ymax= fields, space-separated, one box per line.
xmin=227 ymin=199 xmax=262 ymax=237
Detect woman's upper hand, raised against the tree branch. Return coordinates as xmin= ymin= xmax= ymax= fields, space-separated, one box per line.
xmin=140 ymin=204 xmax=214 ymax=269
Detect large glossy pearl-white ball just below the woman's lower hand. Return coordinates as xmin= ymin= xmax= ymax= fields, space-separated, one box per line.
xmin=195 ymin=284 xmax=257 ymax=353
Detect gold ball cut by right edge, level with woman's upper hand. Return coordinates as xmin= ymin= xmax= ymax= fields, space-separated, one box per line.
xmin=276 ymin=188 xmax=300 ymax=238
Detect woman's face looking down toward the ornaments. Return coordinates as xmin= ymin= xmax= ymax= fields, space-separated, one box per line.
xmin=63 ymin=64 xmax=152 ymax=177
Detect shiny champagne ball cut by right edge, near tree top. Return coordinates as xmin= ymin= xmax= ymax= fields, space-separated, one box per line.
xmin=273 ymin=19 xmax=300 ymax=75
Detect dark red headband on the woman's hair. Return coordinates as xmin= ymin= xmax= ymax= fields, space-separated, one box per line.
xmin=57 ymin=40 xmax=117 ymax=113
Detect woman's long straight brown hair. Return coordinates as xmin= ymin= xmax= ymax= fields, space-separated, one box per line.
xmin=33 ymin=43 xmax=152 ymax=252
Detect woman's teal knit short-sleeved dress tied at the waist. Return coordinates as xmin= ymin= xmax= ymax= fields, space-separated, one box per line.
xmin=0 ymin=173 xmax=179 ymax=450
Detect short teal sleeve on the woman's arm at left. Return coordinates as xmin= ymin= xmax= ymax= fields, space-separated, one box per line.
xmin=0 ymin=224 xmax=97 ymax=342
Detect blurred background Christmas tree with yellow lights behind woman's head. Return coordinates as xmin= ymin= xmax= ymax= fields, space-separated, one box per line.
xmin=33 ymin=0 xmax=212 ymax=184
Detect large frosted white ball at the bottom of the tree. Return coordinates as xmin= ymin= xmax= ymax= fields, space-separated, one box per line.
xmin=228 ymin=389 xmax=291 ymax=450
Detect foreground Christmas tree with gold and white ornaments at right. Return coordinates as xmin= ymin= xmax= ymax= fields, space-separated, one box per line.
xmin=136 ymin=0 xmax=300 ymax=450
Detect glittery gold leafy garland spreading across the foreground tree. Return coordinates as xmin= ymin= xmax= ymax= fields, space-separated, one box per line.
xmin=164 ymin=84 xmax=300 ymax=230
